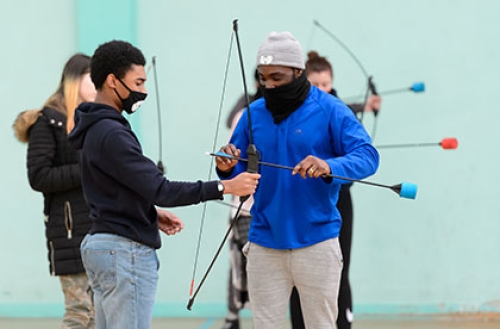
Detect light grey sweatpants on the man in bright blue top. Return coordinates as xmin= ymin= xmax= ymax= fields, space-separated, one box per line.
xmin=243 ymin=238 xmax=342 ymax=329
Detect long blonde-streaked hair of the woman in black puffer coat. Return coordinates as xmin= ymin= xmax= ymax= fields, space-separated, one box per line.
xmin=43 ymin=54 xmax=90 ymax=134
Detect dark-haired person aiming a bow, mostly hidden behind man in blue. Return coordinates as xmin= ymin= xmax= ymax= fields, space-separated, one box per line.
xmin=290 ymin=51 xmax=382 ymax=329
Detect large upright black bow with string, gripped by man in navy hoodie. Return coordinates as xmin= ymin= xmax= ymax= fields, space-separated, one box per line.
xmin=187 ymin=19 xmax=259 ymax=310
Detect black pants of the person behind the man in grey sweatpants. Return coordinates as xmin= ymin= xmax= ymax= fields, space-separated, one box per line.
xmin=290 ymin=184 xmax=353 ymax=329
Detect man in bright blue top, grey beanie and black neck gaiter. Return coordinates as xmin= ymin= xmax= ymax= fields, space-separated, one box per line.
xmin=216 ymin=32 xmax=379 ymax=329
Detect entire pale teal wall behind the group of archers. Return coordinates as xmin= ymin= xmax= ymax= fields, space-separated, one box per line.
xmin=0 ymin=0 xmax=500 ymax=316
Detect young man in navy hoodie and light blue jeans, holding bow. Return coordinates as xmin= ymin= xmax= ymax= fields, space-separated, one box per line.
xmin=69 ymin=41 xmax=260 ymax=329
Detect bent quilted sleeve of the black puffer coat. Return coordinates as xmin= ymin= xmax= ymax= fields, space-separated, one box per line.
xmin=27 ymin=117 xmax=81 ymax=193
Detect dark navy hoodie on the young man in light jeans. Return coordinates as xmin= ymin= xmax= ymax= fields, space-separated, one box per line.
xmin=69 ymin=103 xmax=222 ymax=248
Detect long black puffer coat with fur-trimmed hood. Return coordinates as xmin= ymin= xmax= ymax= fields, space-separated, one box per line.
xmin=15 ymin=108 xmax=91 ymax=275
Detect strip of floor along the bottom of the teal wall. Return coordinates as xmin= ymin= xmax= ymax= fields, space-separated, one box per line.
xmin=0 ymin=315 xmax=500 ymax=329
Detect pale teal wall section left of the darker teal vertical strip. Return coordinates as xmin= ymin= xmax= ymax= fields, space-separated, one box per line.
xmin=0 ymin=0 xmax=76 ymax=316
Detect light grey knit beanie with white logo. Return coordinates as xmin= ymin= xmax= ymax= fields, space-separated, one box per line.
xmin=257 ymin=31 xmax=305 ymax=70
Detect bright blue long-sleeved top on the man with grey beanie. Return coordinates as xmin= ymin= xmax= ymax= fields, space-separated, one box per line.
xmin=219 ymin=86 xmax=379 ymax=249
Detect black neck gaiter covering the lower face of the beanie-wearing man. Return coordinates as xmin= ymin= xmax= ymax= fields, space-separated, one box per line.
xmin=259 ymin=73 xmax=311 ymax=124
